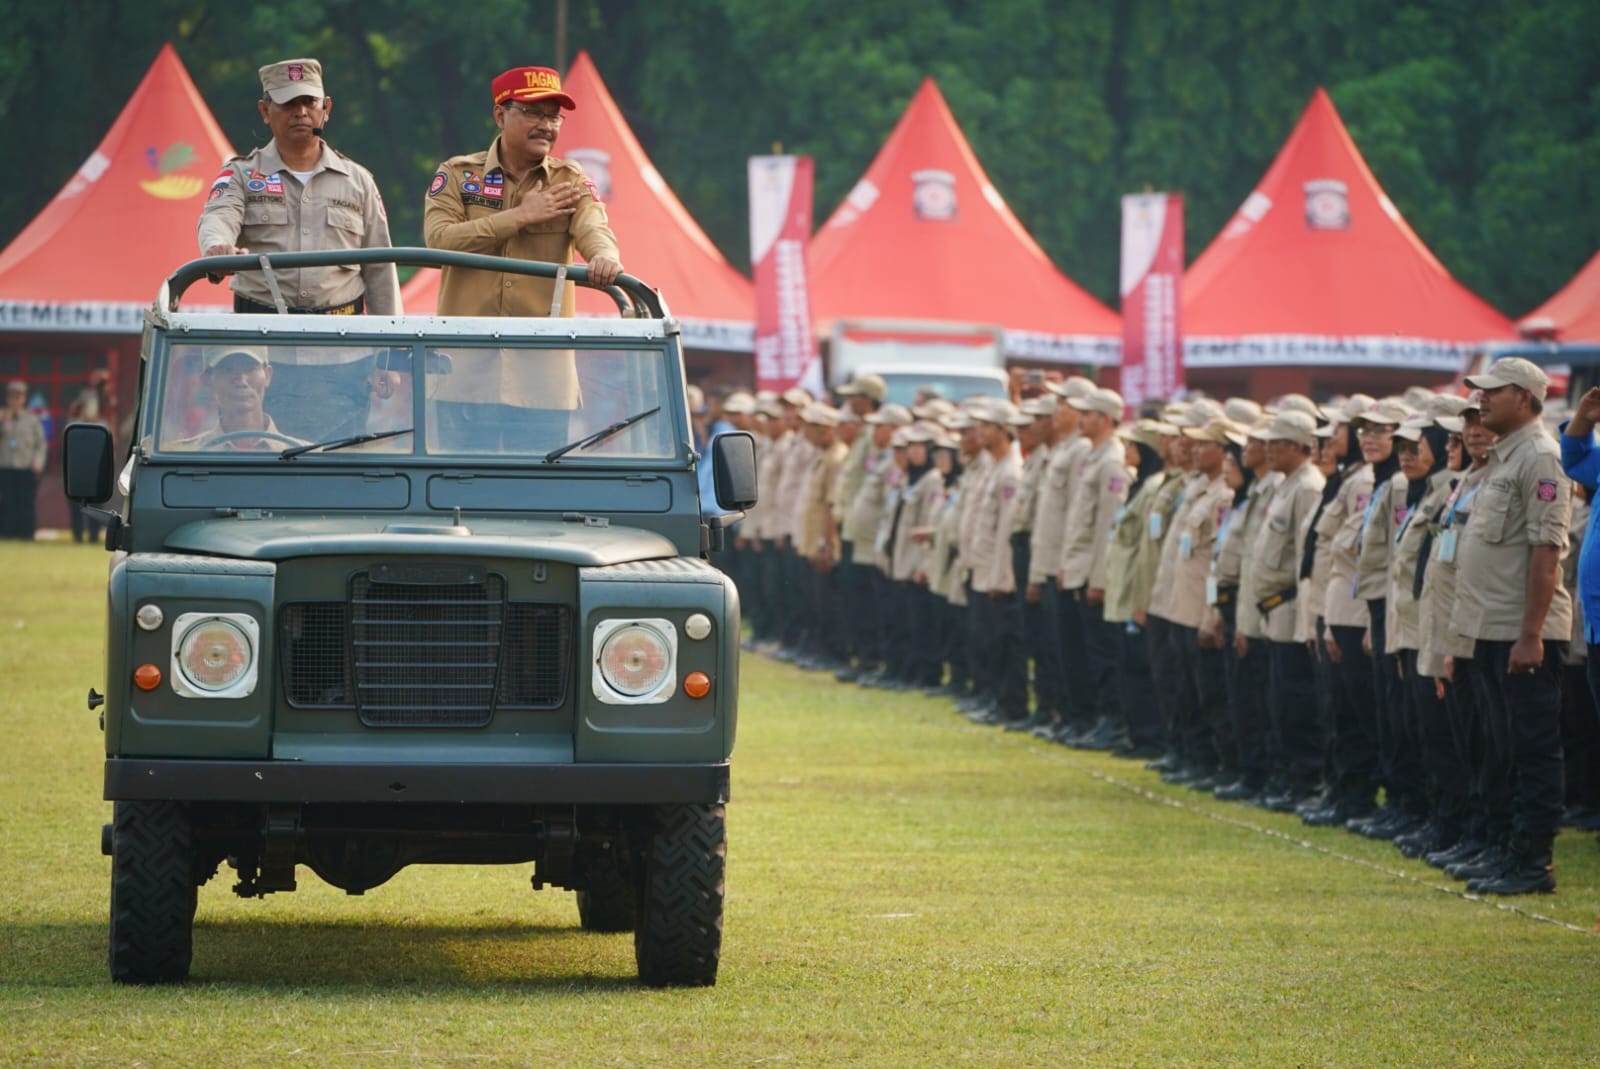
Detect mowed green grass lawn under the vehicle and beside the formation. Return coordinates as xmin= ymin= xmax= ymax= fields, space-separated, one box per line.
xmin=0 ymin=544 xmax=1600 ymax=1067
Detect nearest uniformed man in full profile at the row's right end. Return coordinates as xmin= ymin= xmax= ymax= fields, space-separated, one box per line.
xmin=1451 ymin=357 xmax=1573 ymax=895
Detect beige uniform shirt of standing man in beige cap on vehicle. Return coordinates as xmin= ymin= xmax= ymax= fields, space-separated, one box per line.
xmin=198 ymin=141 xmax=400 ymax=315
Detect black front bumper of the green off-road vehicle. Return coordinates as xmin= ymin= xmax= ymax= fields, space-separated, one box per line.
xmin=106 ymin=757 xmax=728 ymax=805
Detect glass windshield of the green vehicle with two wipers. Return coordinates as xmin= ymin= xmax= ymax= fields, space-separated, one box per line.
xmin=147 ymin=339 xmax=680 ymax=464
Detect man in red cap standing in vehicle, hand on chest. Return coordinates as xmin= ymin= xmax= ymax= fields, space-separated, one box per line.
xmin=422 ymin=67 xmax=630 ymax=451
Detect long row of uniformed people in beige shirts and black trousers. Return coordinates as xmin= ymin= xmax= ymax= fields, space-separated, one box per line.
xmin=741 ymin=358 xmax=1600 ymax=895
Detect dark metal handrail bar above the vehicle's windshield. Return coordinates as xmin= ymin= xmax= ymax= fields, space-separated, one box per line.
xmin=166 ymin=246 xmax=666 ymax=318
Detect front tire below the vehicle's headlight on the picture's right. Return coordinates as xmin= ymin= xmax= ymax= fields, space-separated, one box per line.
xmin=634 ymin=805 xmax=728 ymax=987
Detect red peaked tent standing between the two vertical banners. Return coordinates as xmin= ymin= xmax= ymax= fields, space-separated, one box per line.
xmin=806 ymin=78 xmax=1122 ymax=365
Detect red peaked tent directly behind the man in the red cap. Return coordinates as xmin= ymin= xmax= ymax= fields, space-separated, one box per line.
xmin=402 ymin=51 xmax=755 ymax=352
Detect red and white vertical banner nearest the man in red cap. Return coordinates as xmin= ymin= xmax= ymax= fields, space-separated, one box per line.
xmin=750 ymin=155 xmax=822 ymax=394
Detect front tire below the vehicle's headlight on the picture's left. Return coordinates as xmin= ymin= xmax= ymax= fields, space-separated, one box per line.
xmin=110 ymin=802 xmax=197 ymax=984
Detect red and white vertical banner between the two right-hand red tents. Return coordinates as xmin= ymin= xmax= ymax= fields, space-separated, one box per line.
xmin=1120 ymin=194 xmax=1184 ymax=406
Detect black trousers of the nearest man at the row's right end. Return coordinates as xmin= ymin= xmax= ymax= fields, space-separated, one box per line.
xmin=1472 ymin=639 xmax=1566 ymax=855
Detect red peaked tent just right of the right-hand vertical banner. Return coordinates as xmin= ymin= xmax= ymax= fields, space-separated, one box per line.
xmin=1182 ymin=88 xmax=1517 ymax=392
